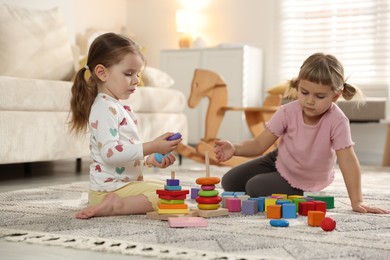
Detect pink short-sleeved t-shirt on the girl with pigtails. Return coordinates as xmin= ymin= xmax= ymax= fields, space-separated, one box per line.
xmin=266 ymin=101 xmax=354 ymax=191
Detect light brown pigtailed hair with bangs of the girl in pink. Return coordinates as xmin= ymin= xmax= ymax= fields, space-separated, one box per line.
xmin=285 ymin=53 xmax=364 ymax=104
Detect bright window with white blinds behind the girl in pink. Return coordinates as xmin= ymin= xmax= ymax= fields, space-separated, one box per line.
xmin=275 ymin=0 xmax=390 ymax=85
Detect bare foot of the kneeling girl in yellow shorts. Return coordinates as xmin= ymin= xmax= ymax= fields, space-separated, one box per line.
xmin=76 ymin=192 xmax=120 ymax=219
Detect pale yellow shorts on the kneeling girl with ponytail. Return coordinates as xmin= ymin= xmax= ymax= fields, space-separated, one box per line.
xmin=88 ymin=179 xmax=165 ymax=210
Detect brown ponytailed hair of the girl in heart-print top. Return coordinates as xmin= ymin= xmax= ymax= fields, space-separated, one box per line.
xmin=69 ymin=33 xmax=145 ymax=134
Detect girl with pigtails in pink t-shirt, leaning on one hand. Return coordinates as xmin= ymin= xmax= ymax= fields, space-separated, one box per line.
xmin=215 ymin=53 xmax=389 ymax=213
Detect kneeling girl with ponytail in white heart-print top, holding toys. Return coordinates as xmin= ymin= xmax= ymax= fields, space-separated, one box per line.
xmin=70 ymin=33 xmax=182 ymax=219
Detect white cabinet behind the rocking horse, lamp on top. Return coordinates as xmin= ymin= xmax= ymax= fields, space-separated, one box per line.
xmin=160 ymin=45 xmax=263 ymax=144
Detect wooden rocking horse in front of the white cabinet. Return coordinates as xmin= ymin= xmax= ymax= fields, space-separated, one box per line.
xmin=176 ymin=69 xmax=282 ymax=166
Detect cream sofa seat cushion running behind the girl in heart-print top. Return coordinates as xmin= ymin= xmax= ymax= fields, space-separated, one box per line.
xmin=0 ymin=76 xmax=187 ymax=113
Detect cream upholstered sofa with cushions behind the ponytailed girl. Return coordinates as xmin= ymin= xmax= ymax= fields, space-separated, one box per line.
xmin=0 ymin=4 xmax=188 ymax=169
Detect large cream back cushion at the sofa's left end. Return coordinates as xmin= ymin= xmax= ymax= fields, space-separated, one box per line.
xmin=0 ymin=4 xmax=74 ymax=80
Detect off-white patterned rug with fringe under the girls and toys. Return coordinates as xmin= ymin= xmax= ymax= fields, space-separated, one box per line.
xmin=0 ymin=166 xmax=390 ymax=260
